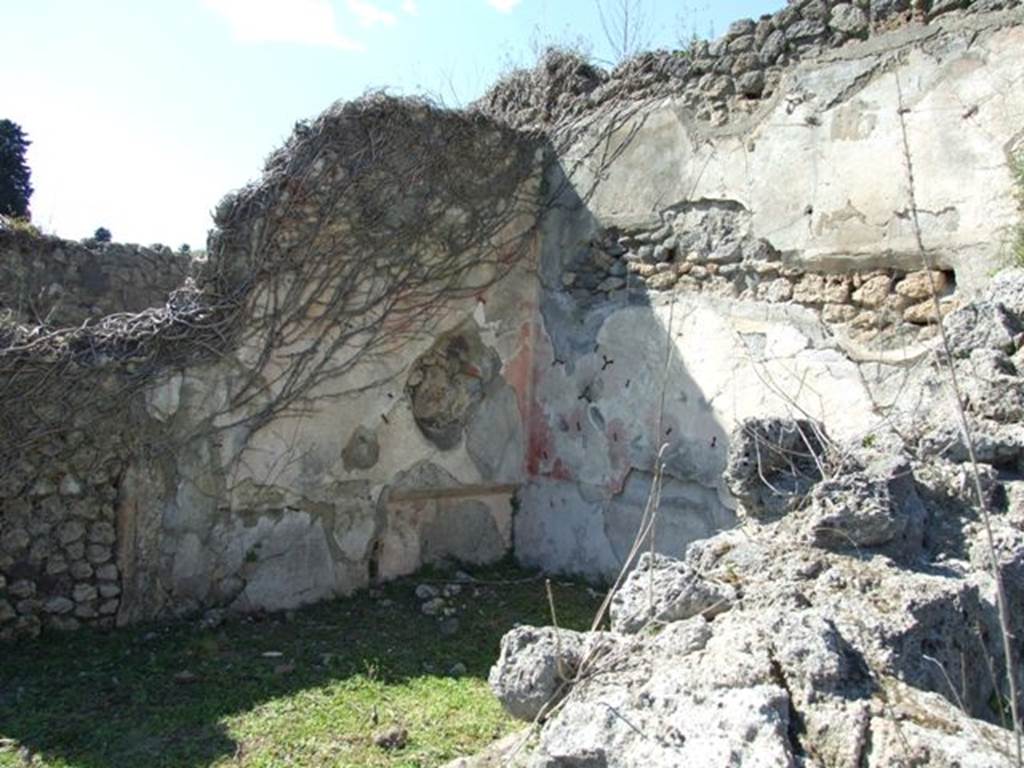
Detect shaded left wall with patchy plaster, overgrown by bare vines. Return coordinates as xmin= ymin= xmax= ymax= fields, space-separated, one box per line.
xmin=0 ymin=97 xmax=541 ymax=636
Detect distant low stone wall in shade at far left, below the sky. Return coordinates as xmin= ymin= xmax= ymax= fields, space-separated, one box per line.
xmin=0 ymin=222 xmax=191 ymax=327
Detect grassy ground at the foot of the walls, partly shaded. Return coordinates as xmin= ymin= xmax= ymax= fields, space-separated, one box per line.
xmin=0 ymin=565 xmax=599 ymax=768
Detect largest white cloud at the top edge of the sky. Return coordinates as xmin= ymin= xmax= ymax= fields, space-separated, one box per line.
xmin=204 ymin=0 xmax=365 ymax=51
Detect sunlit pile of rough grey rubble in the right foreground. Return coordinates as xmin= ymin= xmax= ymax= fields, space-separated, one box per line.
xmin=475 ymin=270 xmax=1024 ymax=768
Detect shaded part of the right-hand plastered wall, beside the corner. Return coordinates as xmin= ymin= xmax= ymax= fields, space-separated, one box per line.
xmin=515 ymin=147 xmax=735 ymax=580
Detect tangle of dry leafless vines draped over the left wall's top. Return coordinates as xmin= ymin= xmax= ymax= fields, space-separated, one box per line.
xmin=0 ymin=94 xmax=552 ymax=479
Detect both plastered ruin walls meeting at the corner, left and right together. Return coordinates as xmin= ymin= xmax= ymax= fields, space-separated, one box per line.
xmin=0 ymin=2 xmax=1024 ymax=637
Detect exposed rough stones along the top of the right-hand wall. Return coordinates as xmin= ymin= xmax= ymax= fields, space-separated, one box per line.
xmin=475 ymin=0 xmax=1020 ymax=128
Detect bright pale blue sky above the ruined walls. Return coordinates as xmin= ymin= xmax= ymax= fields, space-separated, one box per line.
xmin=0 ymin=0 xmax=784 ymax=248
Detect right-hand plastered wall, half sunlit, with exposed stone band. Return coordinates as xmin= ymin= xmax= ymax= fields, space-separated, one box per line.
xmin=516 ymin=3 xmax=1024 ymax=578
